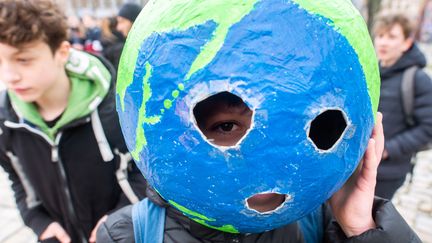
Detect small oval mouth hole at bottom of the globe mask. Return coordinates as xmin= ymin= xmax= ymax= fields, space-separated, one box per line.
xmin=246 ymin=192 xmax=291 ymax=214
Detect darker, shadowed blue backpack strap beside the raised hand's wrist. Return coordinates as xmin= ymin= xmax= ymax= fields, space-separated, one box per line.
xmin=298 ymin=205 xmax=324 ymax=243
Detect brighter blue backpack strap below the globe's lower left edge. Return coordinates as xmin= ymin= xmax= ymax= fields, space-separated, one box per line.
xmin=132 ymin=198 xmax=165 ymax=243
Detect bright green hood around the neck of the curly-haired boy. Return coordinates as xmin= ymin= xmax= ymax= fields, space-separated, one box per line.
xmin=9 ymin=50 xmax=111 ymax=139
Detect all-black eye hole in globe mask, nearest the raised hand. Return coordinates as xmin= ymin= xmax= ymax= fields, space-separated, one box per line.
xmin=308 ymin=109 xmax=348 ymax=151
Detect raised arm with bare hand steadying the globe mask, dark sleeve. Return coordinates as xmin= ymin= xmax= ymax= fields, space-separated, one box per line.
xmin=325 ymin=113 xmax=421 ymax=242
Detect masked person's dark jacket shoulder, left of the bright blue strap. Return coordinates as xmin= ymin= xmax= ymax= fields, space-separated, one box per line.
xmin=97 ymin=205 xmax=135 ymax=243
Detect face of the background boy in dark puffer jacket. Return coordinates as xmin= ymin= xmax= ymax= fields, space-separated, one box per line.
xmin=374 ymin=24 xmax=412 ymax=67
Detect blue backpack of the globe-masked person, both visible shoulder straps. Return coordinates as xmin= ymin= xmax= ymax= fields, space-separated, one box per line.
xmin=132 ymin=198 xmax=324 ymax=243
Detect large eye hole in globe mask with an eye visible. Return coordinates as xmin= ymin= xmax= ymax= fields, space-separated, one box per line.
xmin=193 ymin=91 xmax=253 ymax=147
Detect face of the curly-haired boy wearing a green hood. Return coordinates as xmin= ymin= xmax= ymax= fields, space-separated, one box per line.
xmin=0 ymin=41 xmax=69 ymax=102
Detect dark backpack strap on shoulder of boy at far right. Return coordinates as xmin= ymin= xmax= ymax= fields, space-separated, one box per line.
xmin=401 ymin=66 xmax=418 ymax=126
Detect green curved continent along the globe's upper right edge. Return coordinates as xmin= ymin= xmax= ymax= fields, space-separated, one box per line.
xmin=293 ymin=0 xmax=380 ymax=117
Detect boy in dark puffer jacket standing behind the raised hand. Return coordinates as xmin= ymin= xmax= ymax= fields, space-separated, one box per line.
xmin=373 ymin=13 xmax=432 ymax=199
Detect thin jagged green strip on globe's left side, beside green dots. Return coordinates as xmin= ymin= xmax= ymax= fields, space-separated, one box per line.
xmin=131 ymin=62 xmax=161 ymax=161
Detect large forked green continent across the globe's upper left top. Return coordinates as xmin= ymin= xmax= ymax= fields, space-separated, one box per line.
xmin=117 ymin=0 xmax=258 ymax=110
